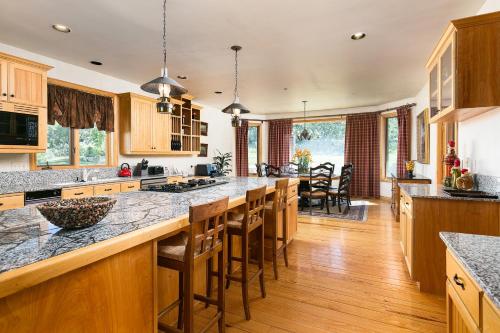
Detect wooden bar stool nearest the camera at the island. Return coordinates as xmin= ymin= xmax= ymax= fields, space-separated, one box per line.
xmin=158 ymin=197 xmax=229 ymax=333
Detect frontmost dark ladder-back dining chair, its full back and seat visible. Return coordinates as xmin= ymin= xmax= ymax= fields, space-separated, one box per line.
xmin=300 ymin=165 xmax=332 ymax=215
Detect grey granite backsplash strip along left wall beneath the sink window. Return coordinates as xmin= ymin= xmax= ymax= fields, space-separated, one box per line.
xmin=0 ymin=168 xmax=118 ymax=188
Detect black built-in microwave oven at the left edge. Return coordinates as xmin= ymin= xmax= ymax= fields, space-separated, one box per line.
xmin=0 ymin=111 xmax=38 ymax=146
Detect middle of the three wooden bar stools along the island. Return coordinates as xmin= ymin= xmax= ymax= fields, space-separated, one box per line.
xmin=226 ymin=186 xmax=266 ymax=320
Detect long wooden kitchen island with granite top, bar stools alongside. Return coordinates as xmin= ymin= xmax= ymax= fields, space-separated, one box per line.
xmin=0 ymin=178 xmax=298 ymax=332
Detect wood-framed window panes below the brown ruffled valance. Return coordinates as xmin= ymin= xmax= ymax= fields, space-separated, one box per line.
xmin=36 ymin=122 xmax=109 ymax=168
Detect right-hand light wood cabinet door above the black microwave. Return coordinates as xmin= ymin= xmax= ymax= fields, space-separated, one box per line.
xmin=8 ymin=63 xmax=47 ymax=106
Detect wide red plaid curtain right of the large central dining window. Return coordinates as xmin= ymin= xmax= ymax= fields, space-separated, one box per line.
xmin=344 ymin=113 xmax=380 ymax=198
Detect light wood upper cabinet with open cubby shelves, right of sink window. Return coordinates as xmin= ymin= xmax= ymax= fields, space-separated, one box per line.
xmin=119 ymin=93 xmax=201 ymax=155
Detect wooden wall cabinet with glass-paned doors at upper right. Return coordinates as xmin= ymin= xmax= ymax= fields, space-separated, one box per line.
xmin=427 ymin=12 xmax=500 ymax=123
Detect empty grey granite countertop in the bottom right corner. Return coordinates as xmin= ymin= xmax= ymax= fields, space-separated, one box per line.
xmin=439 ymin=232 xmax=500 ymax=308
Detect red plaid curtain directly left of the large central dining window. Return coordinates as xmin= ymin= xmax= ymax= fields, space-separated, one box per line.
xmin=267 ymin=119 xmax=292 ymax=167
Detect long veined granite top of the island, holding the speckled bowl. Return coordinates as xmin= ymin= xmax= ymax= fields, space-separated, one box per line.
xmin=0 ymin=177 xmax=277 ymax=274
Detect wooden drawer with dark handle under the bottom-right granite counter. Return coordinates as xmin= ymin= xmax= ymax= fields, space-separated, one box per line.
xmin=446 ymin=250 xmax=481 ymax=326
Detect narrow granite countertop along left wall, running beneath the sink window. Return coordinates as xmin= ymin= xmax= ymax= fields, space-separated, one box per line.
xmin=0 ymin=175 xmax=168 ymax=194
